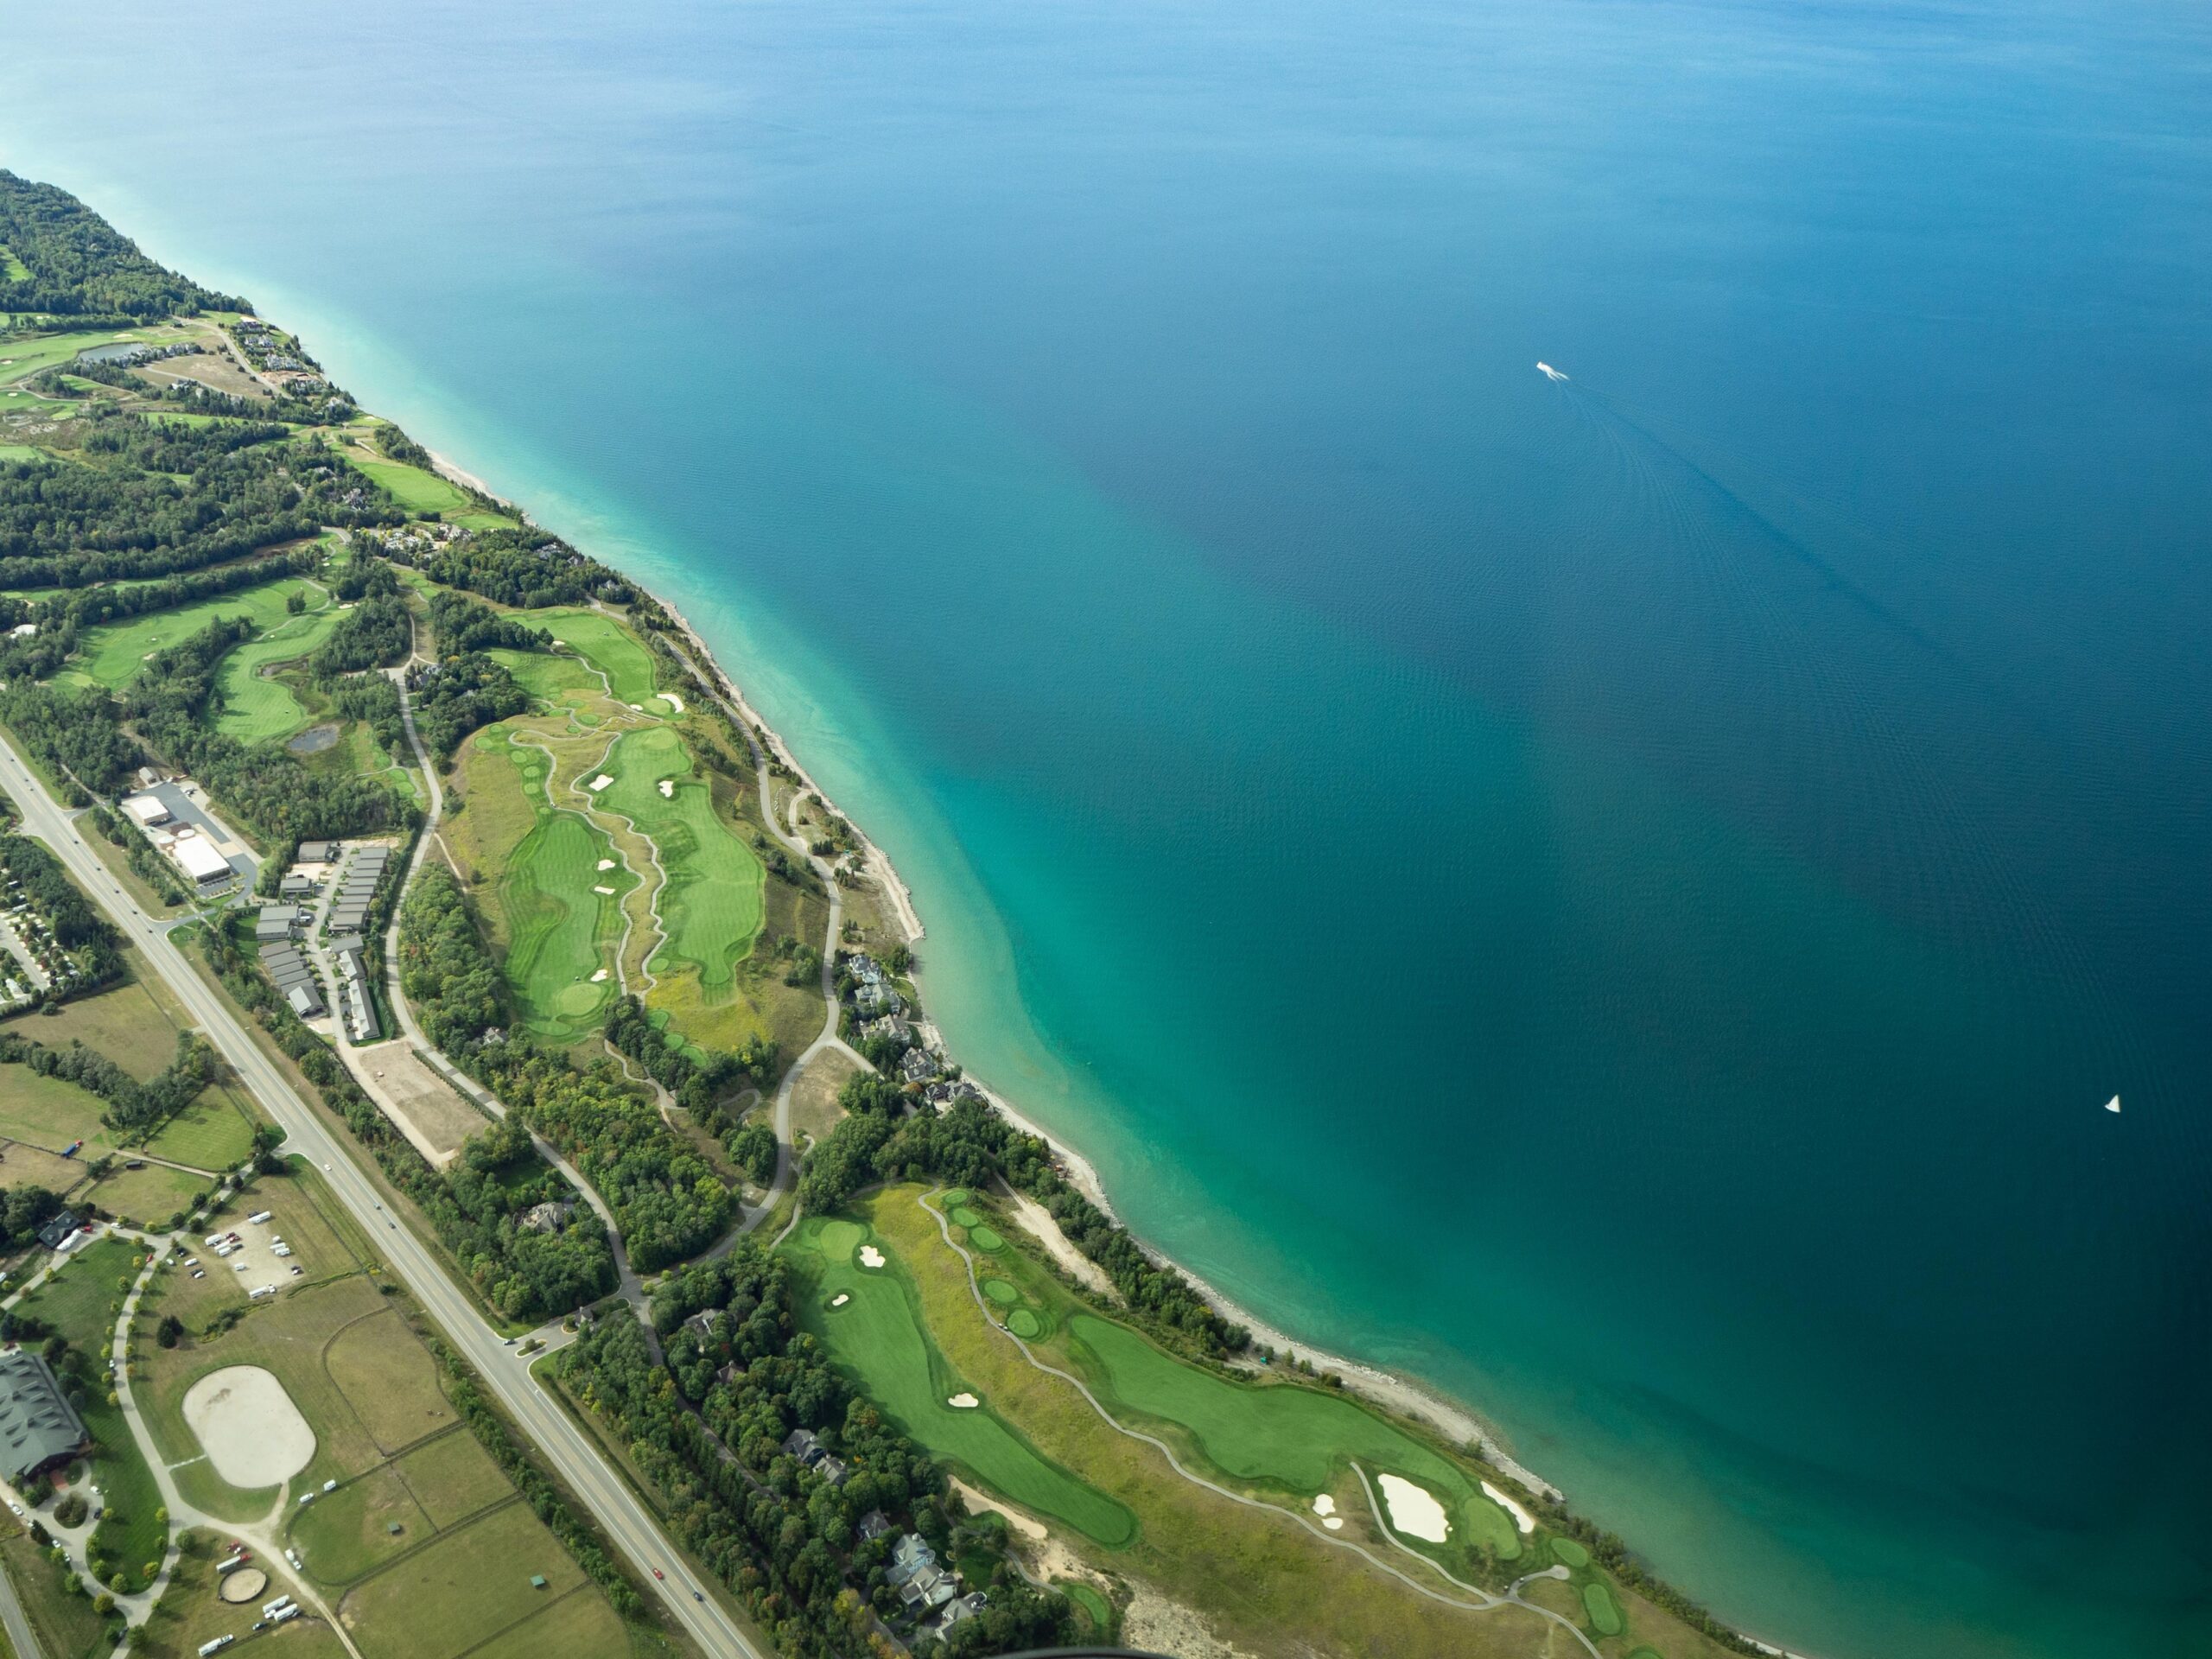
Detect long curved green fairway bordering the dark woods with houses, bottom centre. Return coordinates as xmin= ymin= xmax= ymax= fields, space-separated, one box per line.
xmin=787 ymin=1217 xmax=1137 ymax=1548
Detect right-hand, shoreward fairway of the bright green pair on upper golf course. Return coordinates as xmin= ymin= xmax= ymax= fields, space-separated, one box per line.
xmin=597 ymin=726 xmax=767 ymax=1000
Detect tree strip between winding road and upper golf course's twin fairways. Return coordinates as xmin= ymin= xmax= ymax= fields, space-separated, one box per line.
xmin=400 ymin=862 xmax=736 ymax=1272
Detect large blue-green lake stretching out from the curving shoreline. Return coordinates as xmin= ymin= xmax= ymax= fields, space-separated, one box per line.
xmin=0 ymin=0 xmax=2212 ymax=1659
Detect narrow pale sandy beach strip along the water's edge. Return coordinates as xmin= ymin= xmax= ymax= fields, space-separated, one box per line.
xmin=429 ymin=437 xmax=1566 ymax=1502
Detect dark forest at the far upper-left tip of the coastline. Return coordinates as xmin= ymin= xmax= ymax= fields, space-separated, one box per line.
xmin=0 ymin=168 xmax=252 ymax=321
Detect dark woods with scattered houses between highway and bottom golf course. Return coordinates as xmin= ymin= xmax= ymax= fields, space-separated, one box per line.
xmin=557 ymin=1239 xmax=1075 ymax=1659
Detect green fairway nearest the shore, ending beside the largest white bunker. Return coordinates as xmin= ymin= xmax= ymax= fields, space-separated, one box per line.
xmin=1068 ymin=1312 xmax=1522 ymax=1560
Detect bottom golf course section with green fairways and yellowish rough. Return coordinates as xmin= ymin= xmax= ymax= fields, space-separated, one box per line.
xmin=785 ymin=1185 xmax=1719 ymax=1659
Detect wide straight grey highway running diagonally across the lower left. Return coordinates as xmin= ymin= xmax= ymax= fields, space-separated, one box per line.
xmin=0 ymin=739 xmax=766 ymax=1659
